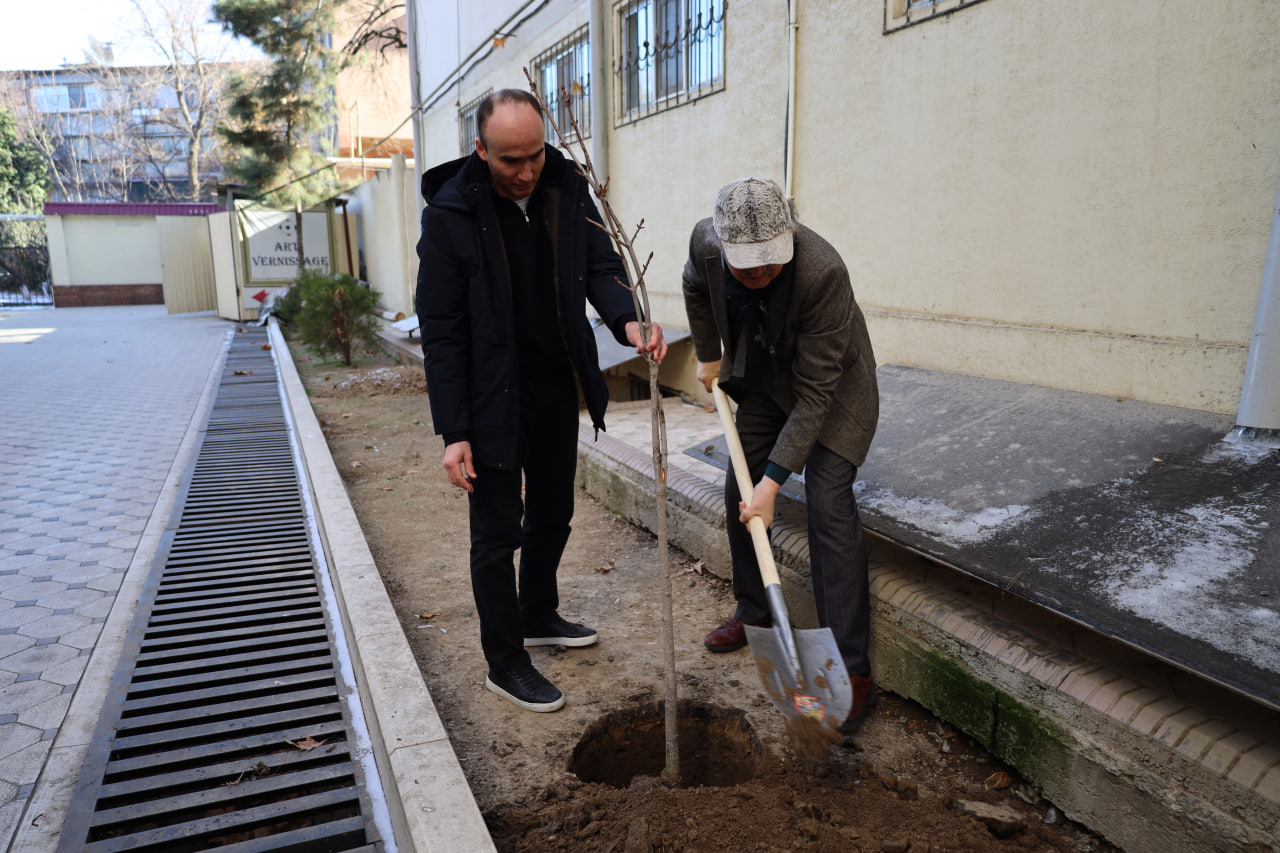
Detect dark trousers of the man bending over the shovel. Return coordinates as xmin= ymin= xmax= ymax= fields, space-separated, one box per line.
xmin=724 ymin=393 xmax=870 ymax=675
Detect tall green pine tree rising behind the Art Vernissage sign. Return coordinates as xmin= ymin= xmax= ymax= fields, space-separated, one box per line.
xmin=212 ymin=0 xmax=339 ymax=207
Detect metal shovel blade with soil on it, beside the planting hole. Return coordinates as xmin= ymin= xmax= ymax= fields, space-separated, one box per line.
xmin=745 ymin=625 xmax=854 ymax=727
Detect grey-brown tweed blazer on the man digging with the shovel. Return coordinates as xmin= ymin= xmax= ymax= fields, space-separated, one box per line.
xmin=684 ymin=219 xmax=879 ymax=471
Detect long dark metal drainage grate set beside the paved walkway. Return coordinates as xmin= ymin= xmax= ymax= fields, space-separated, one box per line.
xmin=59 ymin=330 xmax=383 ymax=853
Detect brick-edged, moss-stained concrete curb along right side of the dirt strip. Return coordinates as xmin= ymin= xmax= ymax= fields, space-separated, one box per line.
xmin=579 ymin=417 xmax=1280 ymax=853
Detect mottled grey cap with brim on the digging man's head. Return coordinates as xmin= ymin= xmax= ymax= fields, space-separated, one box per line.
xmin=712 ymin=178 xmax=795 ymax=269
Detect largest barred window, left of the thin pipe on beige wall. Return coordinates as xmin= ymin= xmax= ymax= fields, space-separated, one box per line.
xmin=614 ymin=0 xmax=726 ymax=124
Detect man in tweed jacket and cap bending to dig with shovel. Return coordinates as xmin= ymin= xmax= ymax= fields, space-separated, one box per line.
xmin=684 ymin=178 xmax=879 ymax=731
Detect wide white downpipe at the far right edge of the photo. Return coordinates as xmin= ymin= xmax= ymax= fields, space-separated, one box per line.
xmin=1231 ymin=172 xmax=1280 ymax=439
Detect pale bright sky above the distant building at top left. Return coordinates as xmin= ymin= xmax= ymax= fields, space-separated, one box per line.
xmin=0 ymin=0 xmax=259 ymax=70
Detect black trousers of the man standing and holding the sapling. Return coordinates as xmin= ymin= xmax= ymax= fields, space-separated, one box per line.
xmin=468 ymin=374 xmax=577 ymax=671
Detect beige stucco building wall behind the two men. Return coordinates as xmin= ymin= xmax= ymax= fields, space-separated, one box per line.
xmin=420 ymin=0 xmax=1280 ymax=412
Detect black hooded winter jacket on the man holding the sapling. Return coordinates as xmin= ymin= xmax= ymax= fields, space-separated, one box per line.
xmin=417 ymin=145 xmax=635 ymax=469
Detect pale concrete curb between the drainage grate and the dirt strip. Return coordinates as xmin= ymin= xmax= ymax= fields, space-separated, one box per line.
xmin=270 ymin=320 xmax=495 ymax=853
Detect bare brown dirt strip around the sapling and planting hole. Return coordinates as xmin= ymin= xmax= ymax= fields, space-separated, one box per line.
xmin=294 ymin=351 xmax=1115 ymax=853
